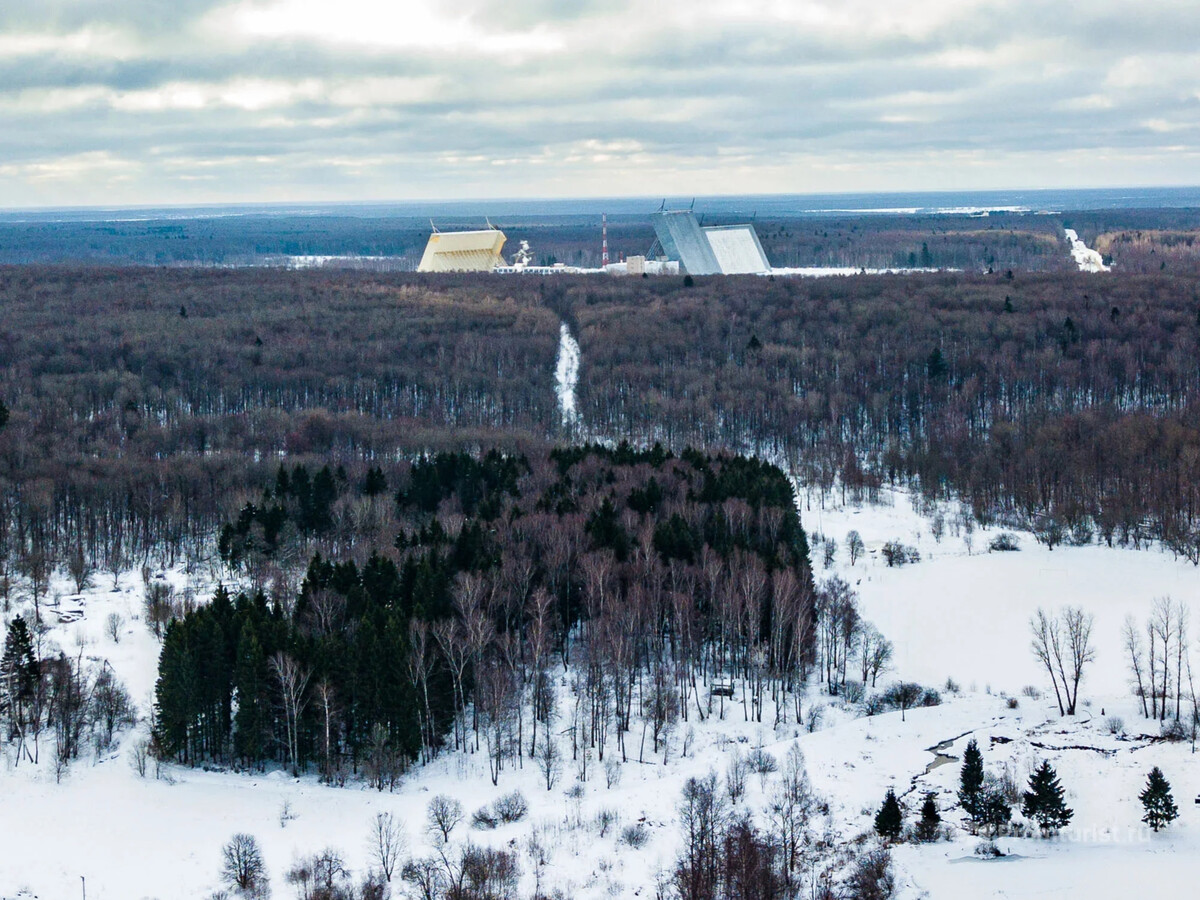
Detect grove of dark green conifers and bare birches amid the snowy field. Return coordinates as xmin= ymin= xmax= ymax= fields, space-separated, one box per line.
xmin=151 ymin=445 xmax=820 ymax=788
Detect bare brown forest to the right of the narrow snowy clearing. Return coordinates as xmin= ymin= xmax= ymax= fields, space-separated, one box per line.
xmin=556 ymin=267 xmax=1200 ymax=560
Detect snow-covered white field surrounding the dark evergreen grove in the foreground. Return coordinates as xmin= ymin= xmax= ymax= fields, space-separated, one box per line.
xmin=0 ymin=493 xmax=1200 ymax=900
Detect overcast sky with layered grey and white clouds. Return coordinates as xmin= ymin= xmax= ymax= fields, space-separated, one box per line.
xmin=0 ymin=0 xmax=1200 ymax=206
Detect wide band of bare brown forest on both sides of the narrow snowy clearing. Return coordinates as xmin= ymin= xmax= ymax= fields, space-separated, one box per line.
xmin=0 ymin=266 xmax=1200 ymax=595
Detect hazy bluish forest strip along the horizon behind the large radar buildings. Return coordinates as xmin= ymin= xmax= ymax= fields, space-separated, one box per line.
xmin=9 ymin=210 xmax=1200 ymax=275
